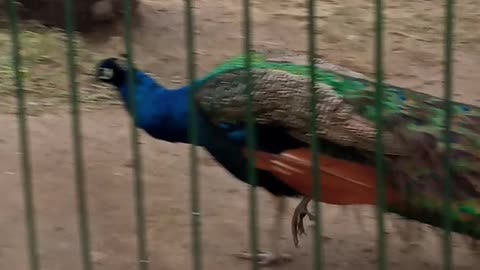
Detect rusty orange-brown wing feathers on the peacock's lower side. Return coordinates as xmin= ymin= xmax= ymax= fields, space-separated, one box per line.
xmin=245 ymin=148 xmax=399 ymax=205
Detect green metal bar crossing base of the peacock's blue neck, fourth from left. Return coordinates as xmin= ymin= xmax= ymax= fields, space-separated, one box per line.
xmin=185 ymin=0 xmax=203 ymax=270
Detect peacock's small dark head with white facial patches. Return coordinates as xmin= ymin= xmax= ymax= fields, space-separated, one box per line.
xmin=95 ymin=57 xmax=128 ymax=87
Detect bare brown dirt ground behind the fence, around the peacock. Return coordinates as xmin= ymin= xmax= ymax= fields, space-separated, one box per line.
xmin=0 ymin=0 xmax=480 ymax=270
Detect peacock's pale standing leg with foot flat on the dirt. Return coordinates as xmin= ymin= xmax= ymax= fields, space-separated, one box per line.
xmin=235 ymin=197 xmax=292 ymax=266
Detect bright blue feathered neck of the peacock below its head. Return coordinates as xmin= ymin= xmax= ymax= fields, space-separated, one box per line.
xmin=115 ymin=72 xmax=244 ymax=146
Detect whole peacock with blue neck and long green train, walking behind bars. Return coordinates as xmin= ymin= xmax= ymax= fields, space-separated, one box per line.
xmin=96 ymin=50 xmax=480 ymax=264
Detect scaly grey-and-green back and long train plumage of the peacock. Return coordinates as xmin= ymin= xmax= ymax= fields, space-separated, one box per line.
xmin=192 ymin=51 xmax=480 ymax=237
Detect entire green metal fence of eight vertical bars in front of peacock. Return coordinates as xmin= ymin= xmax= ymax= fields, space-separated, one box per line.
xmin=8 ymin=0 xmax=454 ymax=270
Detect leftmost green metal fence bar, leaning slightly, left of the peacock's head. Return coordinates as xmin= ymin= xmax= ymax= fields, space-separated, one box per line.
xmin=8 ymin=0 xmax=40 ymax=270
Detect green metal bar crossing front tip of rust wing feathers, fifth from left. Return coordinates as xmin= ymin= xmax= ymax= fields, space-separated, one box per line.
xmin=243 ymin=0 xmax=258 ymax=270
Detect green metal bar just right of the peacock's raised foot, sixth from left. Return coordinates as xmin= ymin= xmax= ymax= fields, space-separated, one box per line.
xmin=307 ymin=0 xmax=323 ymax=270
